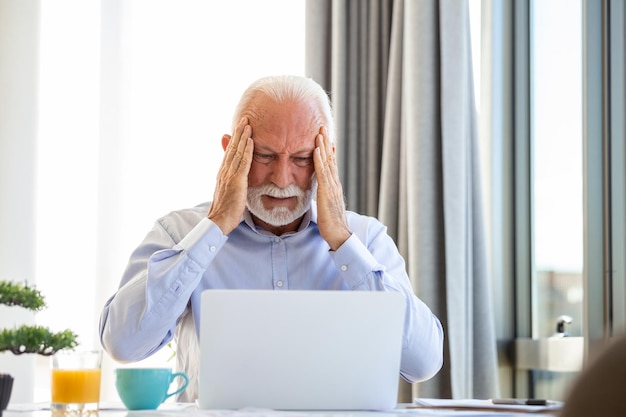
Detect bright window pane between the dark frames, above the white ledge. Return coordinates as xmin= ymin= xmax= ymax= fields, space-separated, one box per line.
xmin=530 ymin=0 xmax=583 ymax=398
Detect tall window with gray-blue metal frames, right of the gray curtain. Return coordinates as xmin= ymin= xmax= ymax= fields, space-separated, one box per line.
xmin=481 ymin=0 xmax=626 ymax=399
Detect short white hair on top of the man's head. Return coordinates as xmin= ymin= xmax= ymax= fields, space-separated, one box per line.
xmin=232 ymin=75 xmax=335 ymax=142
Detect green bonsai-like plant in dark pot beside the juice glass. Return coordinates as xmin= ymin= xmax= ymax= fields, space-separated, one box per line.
xmin=0 ymin=281 xmax=78 ymax=417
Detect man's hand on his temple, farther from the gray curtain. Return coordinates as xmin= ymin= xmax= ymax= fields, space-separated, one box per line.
xmin=208 ymin=117 xmax=254 ymax=235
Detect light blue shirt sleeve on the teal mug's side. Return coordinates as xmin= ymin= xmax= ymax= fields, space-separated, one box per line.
xmin=100 ymin=218 xmax=227 ymax=362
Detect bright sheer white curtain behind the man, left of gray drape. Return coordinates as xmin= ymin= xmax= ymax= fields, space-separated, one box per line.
xmin=28 ymin=0 xmax=304 ymax=401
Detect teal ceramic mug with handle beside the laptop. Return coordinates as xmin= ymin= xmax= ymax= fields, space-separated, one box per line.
xmin=115 ymin=368 xmax=189 ymax=410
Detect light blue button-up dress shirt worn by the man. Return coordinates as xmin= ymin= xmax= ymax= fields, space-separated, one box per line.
xmin=100 ymin=202 xmax=443 ymax=382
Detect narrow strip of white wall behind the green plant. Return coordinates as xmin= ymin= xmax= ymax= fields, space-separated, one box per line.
xmin=0 ymin=0 xmax=39 ymax=402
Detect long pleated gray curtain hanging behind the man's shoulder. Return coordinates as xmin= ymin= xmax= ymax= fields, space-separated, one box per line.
xmin=306 ymin=0 xmax=498 ymax=402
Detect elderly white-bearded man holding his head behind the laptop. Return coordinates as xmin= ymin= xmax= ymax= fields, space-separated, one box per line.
xmin=100 ymin=76 xmax=443 ymax=400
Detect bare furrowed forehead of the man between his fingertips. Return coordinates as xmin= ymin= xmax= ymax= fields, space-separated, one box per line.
xmin=244 ymin=95 xmax=323 ymax=152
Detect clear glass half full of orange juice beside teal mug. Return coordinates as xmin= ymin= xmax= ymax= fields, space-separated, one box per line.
xmin=50 ymin=350 xmax=102 ymax=415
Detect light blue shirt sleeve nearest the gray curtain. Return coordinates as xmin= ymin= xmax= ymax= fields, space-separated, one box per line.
xmin=331 ymin=220 xmax=444 ymax=382
